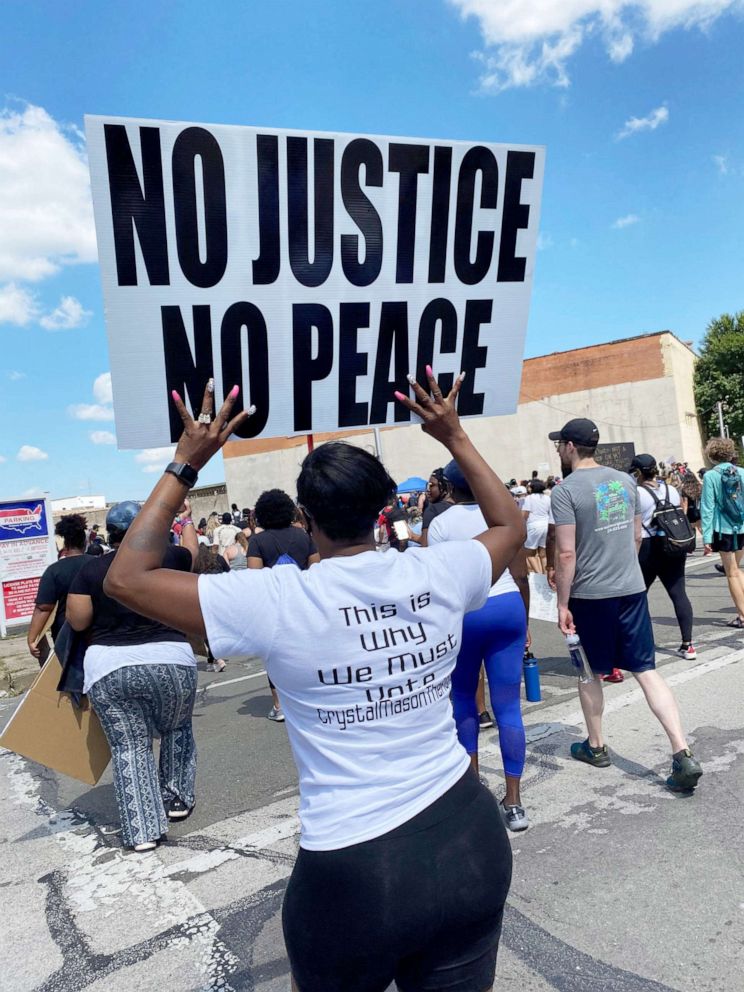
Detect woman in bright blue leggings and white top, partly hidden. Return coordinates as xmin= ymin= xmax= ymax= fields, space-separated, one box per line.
xmin=428 ymin=462 xmax=529 ymax=831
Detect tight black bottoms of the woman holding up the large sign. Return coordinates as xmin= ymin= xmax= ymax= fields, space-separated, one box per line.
xmin=282 ymin=770 xmax=512 ymax=992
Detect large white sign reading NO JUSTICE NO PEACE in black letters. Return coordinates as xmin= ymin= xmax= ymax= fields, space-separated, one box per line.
xmin=86 ymin=117 xmax=544 ymax=448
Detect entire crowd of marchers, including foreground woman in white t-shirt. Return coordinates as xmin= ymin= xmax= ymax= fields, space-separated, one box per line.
xmin=24 ymin=370 xmax=744 ymax=992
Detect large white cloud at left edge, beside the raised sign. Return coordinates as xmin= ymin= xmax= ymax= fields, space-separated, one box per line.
xmin=0 ymin=104 xmax=97 ymax=282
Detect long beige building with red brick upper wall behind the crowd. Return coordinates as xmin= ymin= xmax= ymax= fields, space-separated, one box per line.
xmin=224 ymin=331 xmax=703 ymax=506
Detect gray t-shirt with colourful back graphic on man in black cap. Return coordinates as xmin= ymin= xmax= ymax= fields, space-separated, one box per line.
xmin=550 ymin=466 xmax=646 ymax=599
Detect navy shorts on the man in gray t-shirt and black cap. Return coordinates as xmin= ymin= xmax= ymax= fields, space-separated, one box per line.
xmin=568 ymin=588 xmax=652 ymax=675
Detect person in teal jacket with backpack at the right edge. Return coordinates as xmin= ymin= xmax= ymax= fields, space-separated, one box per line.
xmin=700 ymin=437 xmax=744 ymax=629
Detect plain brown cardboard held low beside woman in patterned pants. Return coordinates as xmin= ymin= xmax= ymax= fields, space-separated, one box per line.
xmin=0 ymin=654 xmax=111 ymax=785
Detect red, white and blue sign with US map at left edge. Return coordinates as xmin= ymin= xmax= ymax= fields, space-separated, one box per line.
xmin=0 ymin=499 xmax=57 ymax=637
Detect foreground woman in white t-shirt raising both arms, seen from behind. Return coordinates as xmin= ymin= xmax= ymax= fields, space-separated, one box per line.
xmin=107 ymin=369 xmax=525 ymax=992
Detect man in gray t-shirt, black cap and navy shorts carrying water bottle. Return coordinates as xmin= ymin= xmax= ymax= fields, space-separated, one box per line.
xmin=548 ymin=418 xmax=703 ymax=792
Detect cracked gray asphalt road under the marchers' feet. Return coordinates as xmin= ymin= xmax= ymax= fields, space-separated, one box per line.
xmin=0 ymin=558 xmax=744 ymax=992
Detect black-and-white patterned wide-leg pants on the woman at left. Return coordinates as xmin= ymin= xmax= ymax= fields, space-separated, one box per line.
xmin=89 ymin=665 xmax=196 ymax=847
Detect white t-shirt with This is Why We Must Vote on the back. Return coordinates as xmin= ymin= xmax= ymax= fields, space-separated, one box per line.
xmin=199 ymin=544 xmax=491 ymax=851
